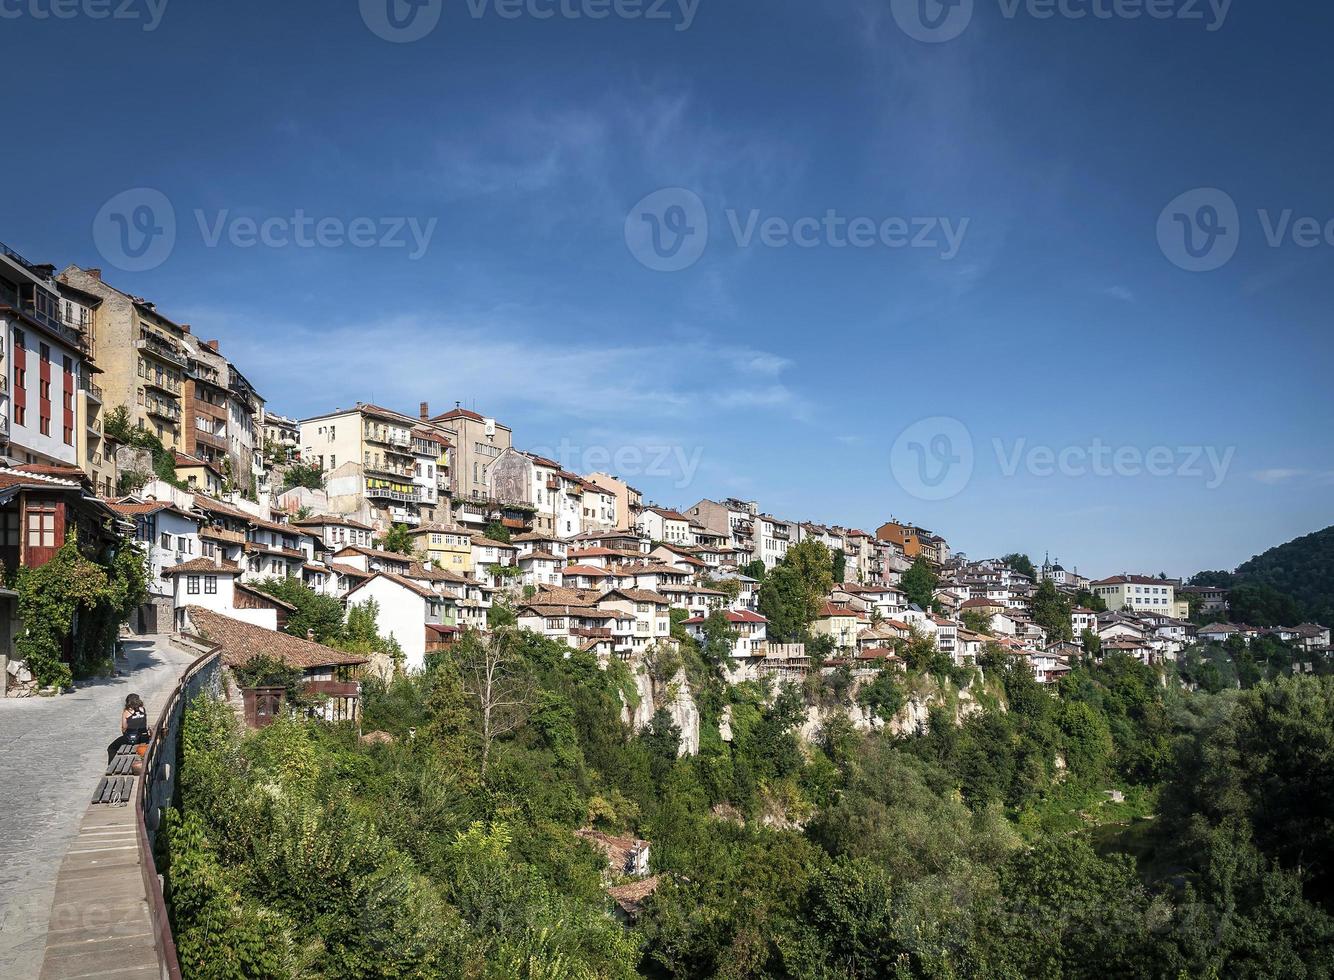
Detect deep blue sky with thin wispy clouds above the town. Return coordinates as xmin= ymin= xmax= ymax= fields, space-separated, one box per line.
xmin=0 ymin=0 xmax=1334 ymax=575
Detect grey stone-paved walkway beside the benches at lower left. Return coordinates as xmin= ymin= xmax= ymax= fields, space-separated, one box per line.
xmin=0 ymin=637 xmax=193 ymax=980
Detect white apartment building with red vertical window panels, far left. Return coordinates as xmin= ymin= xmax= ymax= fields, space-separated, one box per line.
xmin=0 ymin=244 xmax=104 ymax=493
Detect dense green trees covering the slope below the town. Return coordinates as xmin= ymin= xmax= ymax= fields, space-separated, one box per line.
xmin=165 ymin=633 xmax=1334 ymax=980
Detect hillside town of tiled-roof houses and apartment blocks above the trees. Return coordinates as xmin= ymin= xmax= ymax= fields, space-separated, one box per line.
xmin=0 ymin=247 xmax=1330 ymax=695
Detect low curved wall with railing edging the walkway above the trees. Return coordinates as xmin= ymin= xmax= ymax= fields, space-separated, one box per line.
xmin=135 ymin=641 xmax=223 ymax=980
